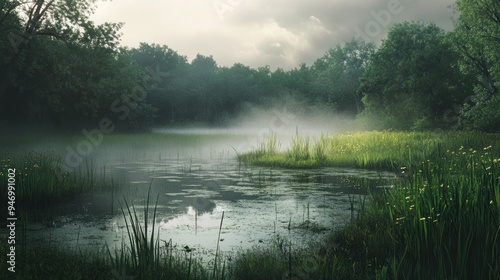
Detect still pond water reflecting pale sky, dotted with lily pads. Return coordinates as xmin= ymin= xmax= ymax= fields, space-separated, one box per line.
xmin=1 ymin=129 xmax=395 ymax=260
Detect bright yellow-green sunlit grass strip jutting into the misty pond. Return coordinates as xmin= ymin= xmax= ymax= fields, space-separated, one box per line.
xmin=239 ymin=131 xmax=500 ymax=171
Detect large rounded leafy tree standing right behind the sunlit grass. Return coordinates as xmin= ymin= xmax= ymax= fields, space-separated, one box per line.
xmin=360 ymin=22 xmax=470 ymax=129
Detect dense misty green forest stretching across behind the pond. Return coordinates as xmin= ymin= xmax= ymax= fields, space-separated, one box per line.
xmin=0 ymin=0 xmax=500 ymax=132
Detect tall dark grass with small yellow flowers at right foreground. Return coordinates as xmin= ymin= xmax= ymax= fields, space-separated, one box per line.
xmin=383 ymin=146 xmax=500 ymax=279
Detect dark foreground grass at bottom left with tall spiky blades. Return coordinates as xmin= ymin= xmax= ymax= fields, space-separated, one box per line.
xmin=0 ymin=188 xmax=213 ymax=280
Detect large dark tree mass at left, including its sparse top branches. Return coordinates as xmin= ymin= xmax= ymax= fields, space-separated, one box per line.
xmin=0 ymin=0 xmax=128 ymax=127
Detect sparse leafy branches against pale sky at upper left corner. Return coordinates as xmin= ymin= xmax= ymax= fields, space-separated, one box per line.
xmin=0 ymin=0 xmax=122 ymax=92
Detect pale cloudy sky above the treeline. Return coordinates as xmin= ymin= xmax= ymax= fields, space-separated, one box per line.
xmin=93 ymin=0 xmax=454 ymax=69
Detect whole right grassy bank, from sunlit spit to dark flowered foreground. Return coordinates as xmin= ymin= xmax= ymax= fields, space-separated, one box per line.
xmin=240 ymin=132 xmax=500 ymax=279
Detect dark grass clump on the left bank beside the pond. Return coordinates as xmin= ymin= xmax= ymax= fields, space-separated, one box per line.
xmin=0 ymin=151 xmax=116 ymax=221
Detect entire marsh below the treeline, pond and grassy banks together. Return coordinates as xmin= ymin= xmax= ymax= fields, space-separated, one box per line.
xmin=0 ymin=130 xmax=500 ymax=279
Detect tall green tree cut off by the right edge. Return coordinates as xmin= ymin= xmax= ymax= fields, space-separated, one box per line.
xmin=454 ymin=0 xmax=500 ymax=131
